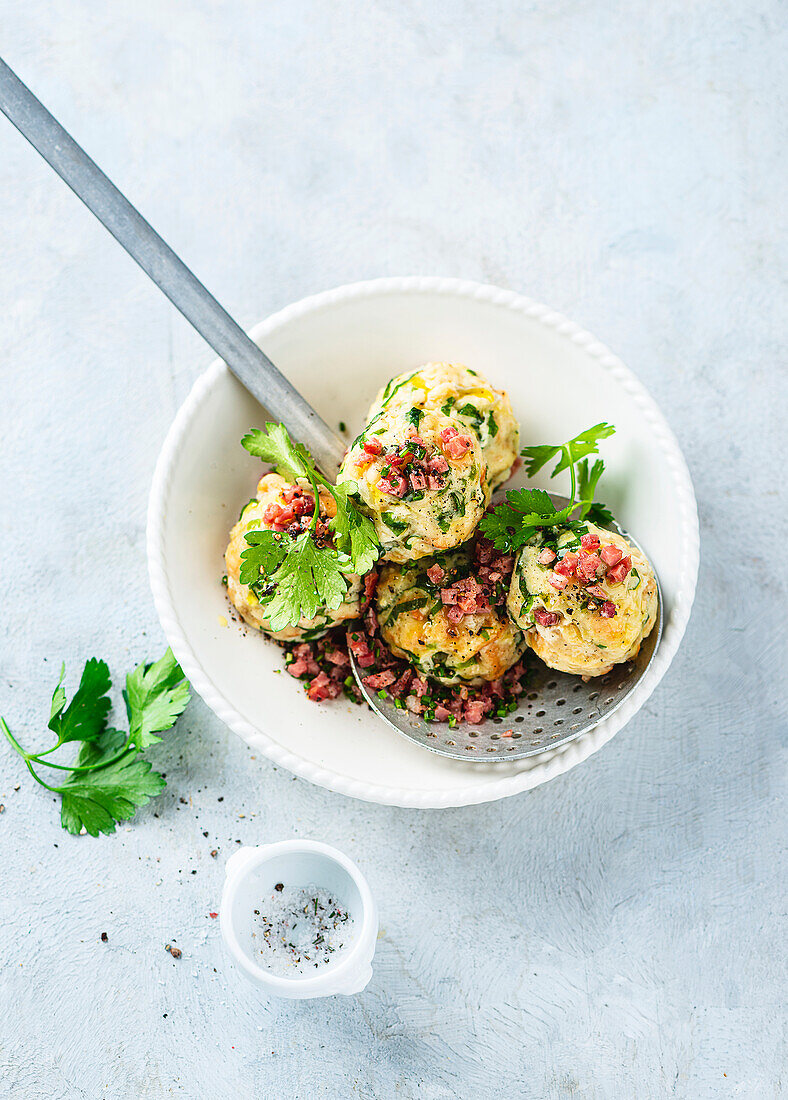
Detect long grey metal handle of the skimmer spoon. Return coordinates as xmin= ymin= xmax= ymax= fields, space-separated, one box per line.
xmin=0 ymin=58 xmax=344 ymax=474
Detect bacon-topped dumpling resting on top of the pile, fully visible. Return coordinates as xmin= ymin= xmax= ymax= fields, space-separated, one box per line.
xmin=337 ymin=404 xmax=490 ymax=561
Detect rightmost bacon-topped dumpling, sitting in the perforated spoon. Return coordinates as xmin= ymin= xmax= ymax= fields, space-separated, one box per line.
xmin=507 ymin=524 xmax=657 ymax=678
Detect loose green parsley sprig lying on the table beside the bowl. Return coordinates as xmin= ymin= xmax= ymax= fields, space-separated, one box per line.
xmin=0 ymin=649 xmax=189 ymax=836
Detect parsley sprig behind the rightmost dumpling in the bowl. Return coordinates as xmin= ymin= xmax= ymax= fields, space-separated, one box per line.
xmin=479 ymin=421 xmax=615 ymax=553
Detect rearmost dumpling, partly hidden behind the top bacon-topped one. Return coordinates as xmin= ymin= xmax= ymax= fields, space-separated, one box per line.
xmin=366 ymin=363 xmax=519 ymax=490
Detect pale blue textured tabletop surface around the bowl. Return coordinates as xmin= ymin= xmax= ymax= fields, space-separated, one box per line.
xmin=0 ymin=0 xmax=788 ymax=1100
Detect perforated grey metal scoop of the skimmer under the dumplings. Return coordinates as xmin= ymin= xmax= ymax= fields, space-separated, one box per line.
xmin=350 ymin=493 xmax=663 ymax=765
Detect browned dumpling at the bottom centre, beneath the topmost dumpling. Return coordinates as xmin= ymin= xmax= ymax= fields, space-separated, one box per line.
xmin=375 ymin=546 xmax=525 ymax=684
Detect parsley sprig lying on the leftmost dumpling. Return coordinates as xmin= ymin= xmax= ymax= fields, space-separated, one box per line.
xmin=240 ymin=424 xmax=381 ymax=630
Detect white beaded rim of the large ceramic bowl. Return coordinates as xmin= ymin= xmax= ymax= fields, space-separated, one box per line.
xmin=146 ymin=276 xmax=699 ymax=809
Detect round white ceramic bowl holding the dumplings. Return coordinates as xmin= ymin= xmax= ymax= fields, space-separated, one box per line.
xmin=147 ymin=277 xmax=698 ymax=806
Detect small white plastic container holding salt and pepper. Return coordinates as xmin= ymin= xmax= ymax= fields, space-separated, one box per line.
xmin=219 ymin=840 xmax=377 ymax=1000
